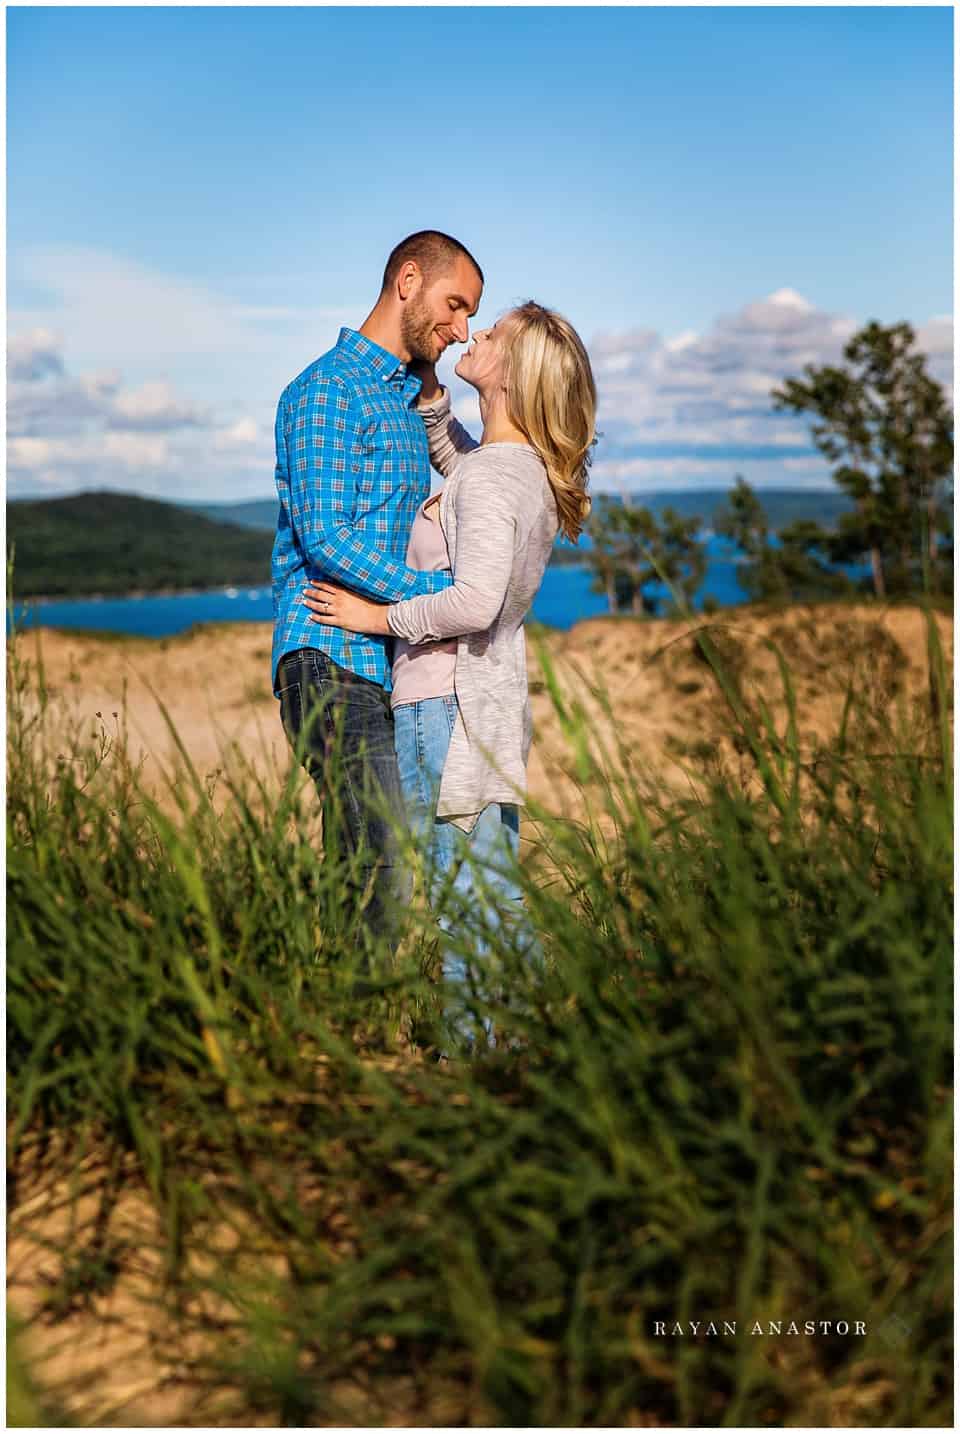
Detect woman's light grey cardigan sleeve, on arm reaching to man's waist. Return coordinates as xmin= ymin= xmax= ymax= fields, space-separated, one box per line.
xmin=386 ymin=460 xmax=518 ymax=642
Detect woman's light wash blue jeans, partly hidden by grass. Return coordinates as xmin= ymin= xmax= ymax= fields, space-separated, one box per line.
xmin=393 ymin=697 xmax=540 ymax=1037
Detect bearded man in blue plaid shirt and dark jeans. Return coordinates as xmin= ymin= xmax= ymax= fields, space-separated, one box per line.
xmin=273 ymin=229 xmax=484 ymax=938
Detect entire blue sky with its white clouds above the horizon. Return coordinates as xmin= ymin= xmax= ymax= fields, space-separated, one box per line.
xmin=7 ymin=6 xmax=953 ymax=500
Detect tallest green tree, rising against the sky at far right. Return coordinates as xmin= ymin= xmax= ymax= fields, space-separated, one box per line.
xmin=772 ymin=321 xmax=953 ymax=598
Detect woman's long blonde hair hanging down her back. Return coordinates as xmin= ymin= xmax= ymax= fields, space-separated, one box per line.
xmin=501 ymin=300 xmax=597 ymax=542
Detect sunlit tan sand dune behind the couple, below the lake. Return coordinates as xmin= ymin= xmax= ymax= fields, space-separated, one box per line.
xmin=17 ymin=604 xmax=953 ymax=810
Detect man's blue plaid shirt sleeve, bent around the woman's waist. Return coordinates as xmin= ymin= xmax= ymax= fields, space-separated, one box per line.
xmin=284 ymin=376 xmax=452 ymax=602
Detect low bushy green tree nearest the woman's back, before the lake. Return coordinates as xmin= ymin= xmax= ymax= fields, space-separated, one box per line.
xmin=590 ymin=498 xmax=706 ymax=615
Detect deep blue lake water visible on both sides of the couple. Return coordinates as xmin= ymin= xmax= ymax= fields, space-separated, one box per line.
xmin=14 ymin=547 xmax=745 ymax=637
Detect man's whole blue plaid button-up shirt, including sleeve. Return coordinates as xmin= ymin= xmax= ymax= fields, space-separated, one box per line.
xmin=273 ymin=328 xmax=453 ymax=693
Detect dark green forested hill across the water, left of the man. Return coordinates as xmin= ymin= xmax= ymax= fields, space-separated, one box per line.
xmin=7 ymin=492 xmax=273 ymax=598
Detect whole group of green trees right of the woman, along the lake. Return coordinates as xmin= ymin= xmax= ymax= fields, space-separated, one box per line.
xmin=587 ymin=323 xmax=953 ymax=612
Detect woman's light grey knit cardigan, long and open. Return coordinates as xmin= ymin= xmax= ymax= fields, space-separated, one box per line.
xmin=387 ymin=390 xmax=558 ymax=832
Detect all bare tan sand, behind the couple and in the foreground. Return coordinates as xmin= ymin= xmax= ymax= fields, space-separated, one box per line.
xmin=9 ymin=605 xmax=953 ymax=1427
